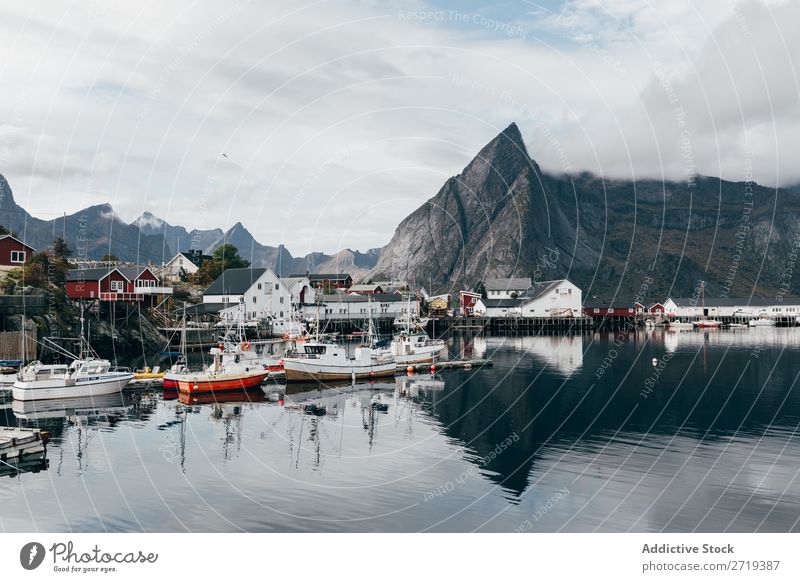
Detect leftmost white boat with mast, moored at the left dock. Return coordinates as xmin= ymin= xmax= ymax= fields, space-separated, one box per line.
xmin=12 ymin=313 xmax=133 ymax=400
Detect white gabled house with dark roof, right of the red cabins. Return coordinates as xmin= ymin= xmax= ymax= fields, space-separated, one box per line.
xmin=203 ymin=268 xmax=292 ymax=320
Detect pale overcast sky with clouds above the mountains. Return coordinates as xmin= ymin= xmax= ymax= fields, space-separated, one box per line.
xmin=0 ymin=0 xmax=800 ymax=256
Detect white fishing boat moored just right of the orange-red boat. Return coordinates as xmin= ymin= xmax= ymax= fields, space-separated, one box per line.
xmin=283 ymin=340 xmax=396 ymax=382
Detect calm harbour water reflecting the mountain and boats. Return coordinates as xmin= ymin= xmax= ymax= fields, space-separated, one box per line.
xmin=0 ymin=329 xmax=800 ymax=532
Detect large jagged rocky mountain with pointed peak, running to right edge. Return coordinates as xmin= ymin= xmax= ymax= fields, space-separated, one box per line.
xmin=370 ymin=124 xmax=800 ymax=302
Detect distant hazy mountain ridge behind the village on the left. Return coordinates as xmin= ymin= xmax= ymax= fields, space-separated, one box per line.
xmin=0 ymin=174 xmax=380 ymax=279
